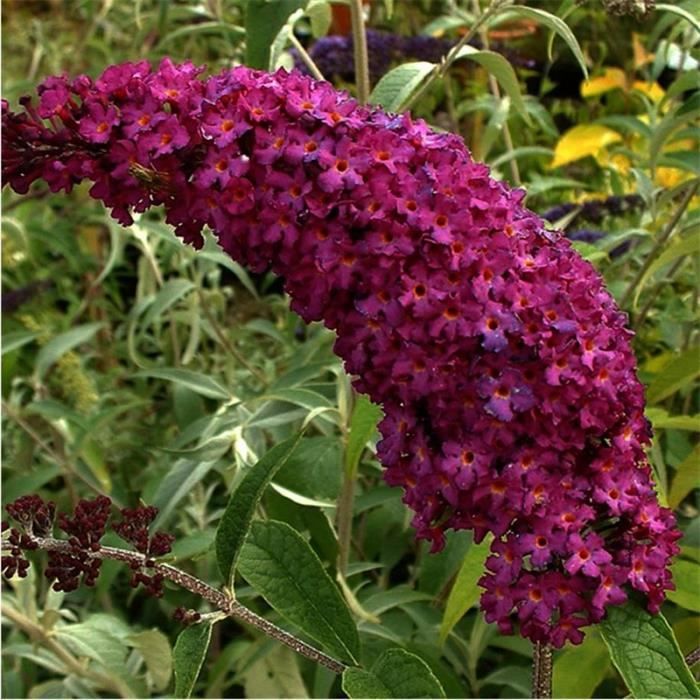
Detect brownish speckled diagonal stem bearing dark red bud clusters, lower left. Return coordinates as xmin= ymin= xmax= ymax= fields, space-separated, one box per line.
xmin=22 ymin=535 xmax=347 ymax=673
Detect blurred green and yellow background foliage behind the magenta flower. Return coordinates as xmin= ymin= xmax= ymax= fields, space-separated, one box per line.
xmin=2 ymin=0 xmax=700 ymax=698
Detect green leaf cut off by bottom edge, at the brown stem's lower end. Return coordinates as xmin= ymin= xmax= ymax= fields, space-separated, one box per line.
xmin=342 ymin=649 xmax=445 ymax=698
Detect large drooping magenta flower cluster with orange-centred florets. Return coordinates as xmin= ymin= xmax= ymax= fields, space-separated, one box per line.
xmin=2 ymin=59 xmax=679 ymax=646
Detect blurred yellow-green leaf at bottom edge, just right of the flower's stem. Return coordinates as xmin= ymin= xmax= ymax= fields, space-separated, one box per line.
xmin=552 ymin=632 xmax=610 ymax=698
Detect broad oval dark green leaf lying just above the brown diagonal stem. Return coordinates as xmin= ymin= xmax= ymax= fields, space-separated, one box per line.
xmin=238 ymin=520 xmax=360 ymax=663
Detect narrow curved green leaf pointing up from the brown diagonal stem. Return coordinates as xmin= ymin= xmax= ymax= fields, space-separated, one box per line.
xmin=215 ymin=433 xmax=301 ymax=589
